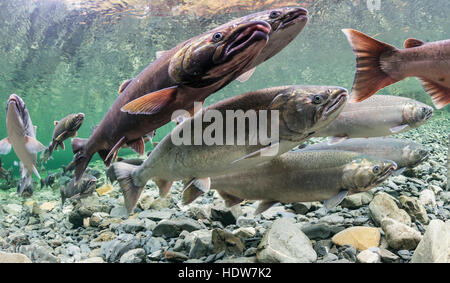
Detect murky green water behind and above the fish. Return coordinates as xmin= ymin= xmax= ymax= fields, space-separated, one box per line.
xmin=0 ymin=0 xmax=450 ymax=178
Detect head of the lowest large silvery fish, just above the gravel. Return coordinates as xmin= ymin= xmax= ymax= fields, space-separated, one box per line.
xmin=342 ymin=155 xmax=397 ymax=193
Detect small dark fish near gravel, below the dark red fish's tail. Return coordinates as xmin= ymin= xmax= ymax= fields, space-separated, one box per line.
xmin=60 ymin=174 xmax=97 ymax=205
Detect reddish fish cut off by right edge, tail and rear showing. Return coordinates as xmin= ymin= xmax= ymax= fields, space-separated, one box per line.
xmin=342 ymin=29 xmax=450 ymax=108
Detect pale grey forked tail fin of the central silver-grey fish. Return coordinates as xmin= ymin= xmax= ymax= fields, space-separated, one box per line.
xmin=111 ymin=162 xmax=144 ymax=213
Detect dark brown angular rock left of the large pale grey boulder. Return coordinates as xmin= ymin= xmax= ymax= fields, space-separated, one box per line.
xmin=211 ymin=228 xmax=244 ymax=255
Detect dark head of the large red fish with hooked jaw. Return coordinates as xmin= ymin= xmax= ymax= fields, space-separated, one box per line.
xmin=169 ymin=21 xmax=271 ymax=88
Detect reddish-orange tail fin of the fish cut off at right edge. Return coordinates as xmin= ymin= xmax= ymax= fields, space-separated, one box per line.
xmin=342 ymin=29 xmax=398 ymax=102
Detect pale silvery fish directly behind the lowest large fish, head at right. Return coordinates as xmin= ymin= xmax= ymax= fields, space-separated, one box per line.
xmin=299 ymin=138 xmax=429 ymax=170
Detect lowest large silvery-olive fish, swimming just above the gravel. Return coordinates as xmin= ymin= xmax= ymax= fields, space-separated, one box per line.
xmin=200 ymin=151 xmax=396 ymax=214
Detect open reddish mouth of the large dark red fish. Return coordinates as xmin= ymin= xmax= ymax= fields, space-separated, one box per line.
xmin=225 ymin=21 xmax=272 ymax=58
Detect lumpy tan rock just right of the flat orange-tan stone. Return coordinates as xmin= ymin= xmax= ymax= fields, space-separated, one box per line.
xmin=381 ymin=217 xmax=422 ymax=250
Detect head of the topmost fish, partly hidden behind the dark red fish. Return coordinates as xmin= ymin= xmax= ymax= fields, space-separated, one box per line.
xmin=245 ymin=7 xmax=308 ymax=63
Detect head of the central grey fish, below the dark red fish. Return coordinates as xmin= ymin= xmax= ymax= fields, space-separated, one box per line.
xmin=271 ymin=86 xmax=348 ymax=140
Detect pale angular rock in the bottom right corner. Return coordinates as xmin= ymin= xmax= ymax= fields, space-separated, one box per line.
xmin=411 ymin=219 xmax=450 ymax=263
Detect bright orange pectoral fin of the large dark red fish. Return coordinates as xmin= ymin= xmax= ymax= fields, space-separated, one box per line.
xmin=121 ymin=86 xmax=178 ymax=115
